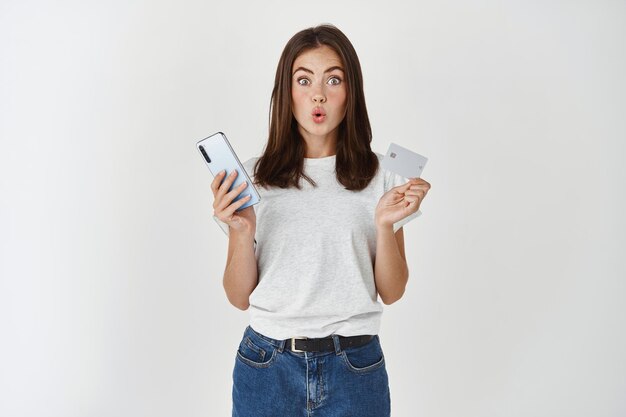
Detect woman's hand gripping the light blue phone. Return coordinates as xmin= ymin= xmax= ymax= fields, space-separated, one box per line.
xmin=211 ymin=169 xmax=256 ymax=236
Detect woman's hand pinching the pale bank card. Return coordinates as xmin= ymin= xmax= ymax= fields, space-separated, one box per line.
xmin=375 ymin=178 xmax=430 ymax=226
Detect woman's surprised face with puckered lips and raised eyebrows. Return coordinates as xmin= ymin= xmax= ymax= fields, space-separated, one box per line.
xmin=291 ymin=45 xmax=347 ymax=144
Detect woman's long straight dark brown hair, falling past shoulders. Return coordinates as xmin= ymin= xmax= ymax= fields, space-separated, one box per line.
xmin=254 ymin=24 xmax=378 ymax=191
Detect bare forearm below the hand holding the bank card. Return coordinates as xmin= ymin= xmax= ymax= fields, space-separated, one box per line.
xmin=374 ymin=225 xmax=409 ymax=305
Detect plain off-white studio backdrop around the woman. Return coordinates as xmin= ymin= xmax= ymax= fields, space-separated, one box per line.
xmin=0 ymin=0 xmax=626 ymax=417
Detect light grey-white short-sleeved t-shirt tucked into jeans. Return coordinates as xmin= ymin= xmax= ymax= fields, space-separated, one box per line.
xmin=215 ymin=152 xmax=421 ymax=339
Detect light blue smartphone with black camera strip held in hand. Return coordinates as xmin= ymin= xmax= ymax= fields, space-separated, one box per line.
xmin=196 ymin=132 xmax=261 ymax=211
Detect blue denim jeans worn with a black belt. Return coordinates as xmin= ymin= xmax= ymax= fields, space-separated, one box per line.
xmin=232 ymin=326 xmax=391 ymax=417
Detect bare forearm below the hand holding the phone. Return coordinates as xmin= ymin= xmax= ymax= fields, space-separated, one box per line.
xmin=223 ymin=227 xmax=258 ymax=310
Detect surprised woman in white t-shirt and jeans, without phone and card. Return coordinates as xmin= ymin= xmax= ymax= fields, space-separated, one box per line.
xmin=211 ymin=25 xmax=430 ymax=417
